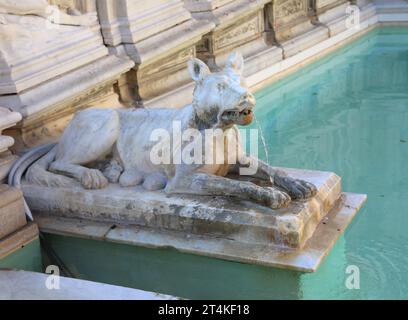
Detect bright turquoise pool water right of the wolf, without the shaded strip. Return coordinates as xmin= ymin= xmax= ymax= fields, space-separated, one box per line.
xmin=250 ymin=28 xmax=408 ymax=299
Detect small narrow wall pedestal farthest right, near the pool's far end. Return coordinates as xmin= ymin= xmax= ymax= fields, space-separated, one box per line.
xmin=315 ymin=0 xmax=352 ymax=37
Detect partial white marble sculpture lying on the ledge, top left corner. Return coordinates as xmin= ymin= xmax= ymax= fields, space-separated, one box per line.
xmin=0 ymin=0 xmax=97 ymax=26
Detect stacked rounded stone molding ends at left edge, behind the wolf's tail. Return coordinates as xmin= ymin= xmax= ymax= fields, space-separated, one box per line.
xmin=0 ymin=107 xmax=22 ymax=183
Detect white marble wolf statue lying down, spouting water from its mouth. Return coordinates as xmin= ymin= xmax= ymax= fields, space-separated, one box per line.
xmin=26 ymin=52 xmax=316 ymax=208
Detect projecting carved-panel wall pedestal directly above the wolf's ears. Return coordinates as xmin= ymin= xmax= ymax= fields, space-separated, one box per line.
xmin=185 ymin=0 xmax=283 ymax=76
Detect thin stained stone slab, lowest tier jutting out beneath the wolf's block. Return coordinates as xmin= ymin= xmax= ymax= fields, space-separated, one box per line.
xmin=36 ymin=193 xmax=366 ymax=272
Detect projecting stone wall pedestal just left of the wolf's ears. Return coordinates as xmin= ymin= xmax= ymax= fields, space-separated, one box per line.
xmin=97 ymin=0 xmax=213 ymax=106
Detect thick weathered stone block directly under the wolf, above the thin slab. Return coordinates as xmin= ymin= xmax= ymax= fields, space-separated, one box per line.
xmin=23 ymin=169 xmax=341 ymax=249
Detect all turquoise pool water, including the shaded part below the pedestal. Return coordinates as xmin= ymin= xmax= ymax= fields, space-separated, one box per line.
xmin=46 ymin=28 xmax=408 ymax=299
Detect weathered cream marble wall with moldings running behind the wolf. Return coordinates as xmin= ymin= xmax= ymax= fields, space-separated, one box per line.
xmin=0 ymin=0 xmax=382 ymax=150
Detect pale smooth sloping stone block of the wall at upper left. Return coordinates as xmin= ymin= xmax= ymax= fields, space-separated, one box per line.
xmin=0 ymin=16 xmax=108 ymax=94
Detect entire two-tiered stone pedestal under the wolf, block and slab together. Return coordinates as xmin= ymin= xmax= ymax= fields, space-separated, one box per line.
xmin=23 ymin=169 xmax=366 ymax=272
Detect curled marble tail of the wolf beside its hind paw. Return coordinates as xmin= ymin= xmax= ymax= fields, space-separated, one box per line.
xmin=25 ymin=146 xmax=74 ymax=187
